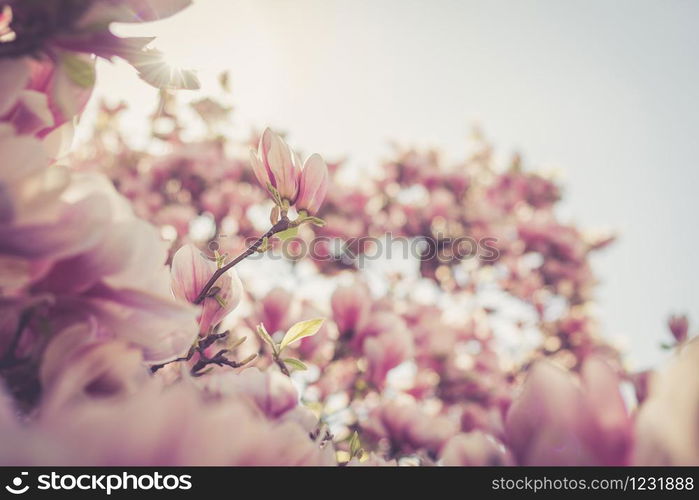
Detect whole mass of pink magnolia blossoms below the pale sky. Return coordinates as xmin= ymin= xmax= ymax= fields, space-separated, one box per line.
xmin=0 ymin=12 xmax=688 ymax=465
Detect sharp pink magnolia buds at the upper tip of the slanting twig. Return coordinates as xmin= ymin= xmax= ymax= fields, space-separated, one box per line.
xmin=250 ymin=128 xmax=328 ymax=215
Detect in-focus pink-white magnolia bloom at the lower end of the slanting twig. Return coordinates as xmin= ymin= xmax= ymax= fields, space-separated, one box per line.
xmin=171 ymin=244 xmax=243 ymax=335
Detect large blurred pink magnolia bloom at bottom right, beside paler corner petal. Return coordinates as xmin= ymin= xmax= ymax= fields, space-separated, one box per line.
xmin=506 ymin=358 xmax=631 ymax=465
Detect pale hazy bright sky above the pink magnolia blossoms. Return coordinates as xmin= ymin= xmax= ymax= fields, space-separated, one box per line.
xmin=75 ymin=0 xmax=699 ymax=368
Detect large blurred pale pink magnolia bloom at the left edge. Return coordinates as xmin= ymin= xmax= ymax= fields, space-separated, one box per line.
xmin=0 ymin=124 xmax=197 ymax=363
